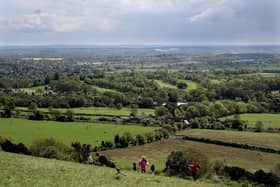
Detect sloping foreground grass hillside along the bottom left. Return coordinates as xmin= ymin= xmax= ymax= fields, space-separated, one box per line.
xmin=0 ymin=151 xmax=223 ymax=187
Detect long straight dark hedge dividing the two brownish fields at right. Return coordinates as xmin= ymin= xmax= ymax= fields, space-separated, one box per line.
xmin=183 ymin=136 xmax=280 ymax=154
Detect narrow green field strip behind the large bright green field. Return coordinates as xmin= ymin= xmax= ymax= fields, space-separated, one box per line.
xmin=17 ymin=107 xmax=154 ymax=116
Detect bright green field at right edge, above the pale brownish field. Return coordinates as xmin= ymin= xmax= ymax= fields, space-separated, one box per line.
xmin=220 ymin=113 xmax=280 ymax=128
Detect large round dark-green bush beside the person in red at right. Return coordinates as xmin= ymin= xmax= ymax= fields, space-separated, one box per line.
xmin=166 ymin=148 xmax=210 ymax=177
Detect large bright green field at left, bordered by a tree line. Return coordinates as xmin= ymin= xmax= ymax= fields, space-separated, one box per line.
xmin=0 ymin=118 xmax=157 ymax=145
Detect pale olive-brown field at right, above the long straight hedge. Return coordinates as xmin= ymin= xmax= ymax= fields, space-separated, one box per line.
xmin=177 ymin=129 xmax=280 ymax=150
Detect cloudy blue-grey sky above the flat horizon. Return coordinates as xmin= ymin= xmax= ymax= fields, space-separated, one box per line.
xmin=0 ymin=0 xmax=280 ymax=45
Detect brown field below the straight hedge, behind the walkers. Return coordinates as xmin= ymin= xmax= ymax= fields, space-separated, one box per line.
xmin=103 ymin=137 xmax=280 ymax=171
